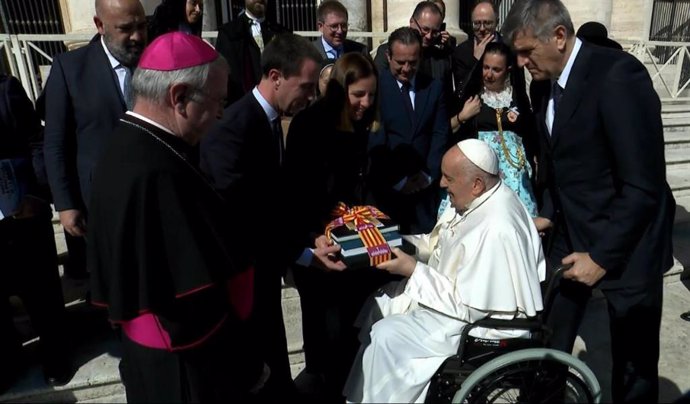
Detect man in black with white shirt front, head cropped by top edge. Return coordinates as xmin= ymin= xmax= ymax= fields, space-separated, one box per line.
xmin=216 ymin=0 xmax=290 ymax=104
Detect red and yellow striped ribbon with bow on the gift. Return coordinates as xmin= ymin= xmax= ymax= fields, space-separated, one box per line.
xmin=326 ymin=202 xmax=393 ymax=266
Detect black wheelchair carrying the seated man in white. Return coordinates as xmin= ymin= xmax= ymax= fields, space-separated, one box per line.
xmin=424 ymin=267 xmax=601 ymax=404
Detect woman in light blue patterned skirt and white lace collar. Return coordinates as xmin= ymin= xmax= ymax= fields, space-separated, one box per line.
xmin=441 ymin=42 xmax=537 ymax=217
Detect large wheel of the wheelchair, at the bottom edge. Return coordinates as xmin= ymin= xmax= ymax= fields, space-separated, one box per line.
xmin=452 ymin=348 xmax=601 ymax=403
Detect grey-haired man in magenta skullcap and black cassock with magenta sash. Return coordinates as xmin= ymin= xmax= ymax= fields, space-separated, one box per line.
xmin=88 ymin=32 xmax=270 ymax=403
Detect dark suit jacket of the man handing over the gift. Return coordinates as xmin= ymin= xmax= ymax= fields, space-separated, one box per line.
xmin=200 ymin=92 xmax=296 ymax=269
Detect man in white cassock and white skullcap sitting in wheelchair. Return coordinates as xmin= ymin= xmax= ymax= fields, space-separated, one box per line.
xmin=344 ymin=139 xmax=545 ymax=403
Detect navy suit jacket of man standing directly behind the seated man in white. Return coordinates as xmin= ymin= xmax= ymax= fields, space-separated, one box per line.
xmin=369 ymin=69 xmax=450 ymax=233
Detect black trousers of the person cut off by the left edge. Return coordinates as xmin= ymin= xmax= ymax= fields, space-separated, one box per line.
xmin=0 ymin=212 xmax=67 ymax=375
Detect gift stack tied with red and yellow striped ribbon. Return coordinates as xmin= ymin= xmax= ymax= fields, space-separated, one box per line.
xmin=326 ymin=203 xmax=414 ymax=269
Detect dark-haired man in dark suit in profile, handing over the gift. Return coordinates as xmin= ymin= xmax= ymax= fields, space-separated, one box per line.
xmin=201 ymin=34 xmax=344 ymax=402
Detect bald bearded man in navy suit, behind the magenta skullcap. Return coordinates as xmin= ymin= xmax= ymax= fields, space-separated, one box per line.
xmin=44 ymin=0 xmax=146 ymax=237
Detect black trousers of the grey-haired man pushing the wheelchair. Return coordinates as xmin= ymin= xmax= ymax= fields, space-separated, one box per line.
xmin=547 ymin=235 xmax=663 ymax=403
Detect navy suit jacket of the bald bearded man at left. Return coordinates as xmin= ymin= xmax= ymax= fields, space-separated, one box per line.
xmin=44 ymin=35 xmax=127 ymax=211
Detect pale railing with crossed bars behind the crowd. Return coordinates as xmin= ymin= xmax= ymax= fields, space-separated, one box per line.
xmin=0 ymin=31 xmax=690 ymax=102
